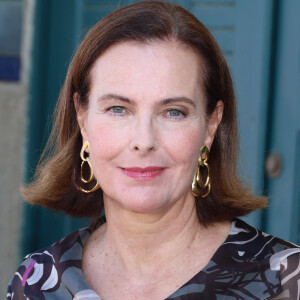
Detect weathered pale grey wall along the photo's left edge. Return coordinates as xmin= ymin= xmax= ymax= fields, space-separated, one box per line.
xmin=0 ymin=0 xmax=35 ymax=299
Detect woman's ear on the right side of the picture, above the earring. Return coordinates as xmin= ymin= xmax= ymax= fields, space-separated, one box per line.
xmin=204 ymin=100 xmax=224 ymax=149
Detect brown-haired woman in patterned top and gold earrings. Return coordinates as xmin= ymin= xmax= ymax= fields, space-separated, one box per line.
xmin=8 ymin=1 xmax=300 ymax=300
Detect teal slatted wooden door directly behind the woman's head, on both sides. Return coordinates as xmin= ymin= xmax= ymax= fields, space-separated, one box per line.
xmin=22 ymin=0 xmax=284 ymax=254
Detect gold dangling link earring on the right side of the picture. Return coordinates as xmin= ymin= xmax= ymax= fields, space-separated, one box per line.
xmin=192 ymin=146 xmax=211 ymax=198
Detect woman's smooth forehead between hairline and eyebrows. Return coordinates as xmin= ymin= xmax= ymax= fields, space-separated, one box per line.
xmin=91 ymin=41 xmax=203 ymax=101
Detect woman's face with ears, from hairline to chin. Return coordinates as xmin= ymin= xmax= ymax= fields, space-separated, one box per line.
xmin=75 ymin=41 xmax=222 ymax=213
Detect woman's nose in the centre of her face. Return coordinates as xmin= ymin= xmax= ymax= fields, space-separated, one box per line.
xmin=129 ymin=118 xmax=157 ymax=154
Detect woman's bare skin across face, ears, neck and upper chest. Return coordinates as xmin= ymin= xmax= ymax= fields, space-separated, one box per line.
xmin=74 ymin=41 xmax=230 ymax=299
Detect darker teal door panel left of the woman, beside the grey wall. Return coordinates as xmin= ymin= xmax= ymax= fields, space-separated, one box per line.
xmin=20 ymin=0 xmax=87 ymax=256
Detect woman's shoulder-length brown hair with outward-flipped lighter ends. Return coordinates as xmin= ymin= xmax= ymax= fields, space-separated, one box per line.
xmin=22 ymin=0 xmax=266 ymax=224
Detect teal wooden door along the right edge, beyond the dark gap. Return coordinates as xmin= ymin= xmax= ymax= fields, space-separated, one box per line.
xmin=265 ymin=0 xmax=300 ymax=244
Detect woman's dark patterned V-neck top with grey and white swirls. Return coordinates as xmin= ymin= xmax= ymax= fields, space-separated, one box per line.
xmin=7 ymin=219 xmax=300 ymax=300
